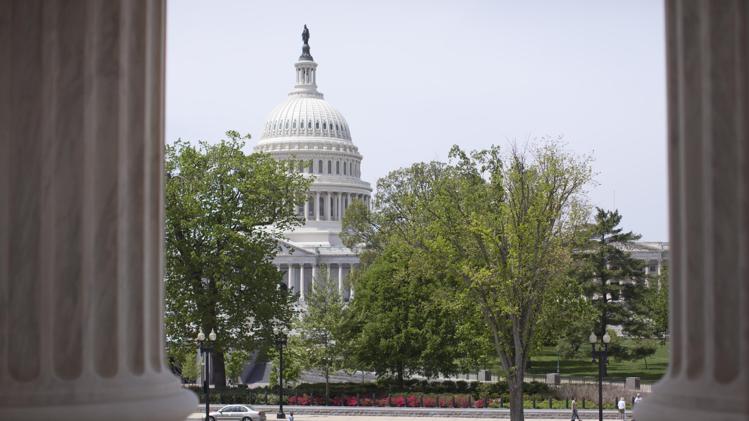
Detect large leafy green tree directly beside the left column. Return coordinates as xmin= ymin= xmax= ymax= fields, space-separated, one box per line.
xmin=165 ymin=131 xmax=310 ymax=388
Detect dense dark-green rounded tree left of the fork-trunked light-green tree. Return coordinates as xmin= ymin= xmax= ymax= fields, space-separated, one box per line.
xmin=349 ymin=238 xmax=468 ymax=386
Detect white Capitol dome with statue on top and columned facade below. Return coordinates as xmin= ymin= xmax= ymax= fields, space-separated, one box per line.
xmin=255 ymin=25 xmax=372 ymax=301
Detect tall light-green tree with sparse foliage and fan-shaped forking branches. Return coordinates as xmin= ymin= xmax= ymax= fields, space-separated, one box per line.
xmin=357 ymin=142 xmax=591 ymax=421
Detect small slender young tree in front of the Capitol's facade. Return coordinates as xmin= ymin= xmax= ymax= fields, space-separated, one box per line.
xmin=297 ymin=267 xmax=346 ymax=402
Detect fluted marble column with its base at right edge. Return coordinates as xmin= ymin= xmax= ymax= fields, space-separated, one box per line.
xmin=635 ymin=0 xmax=749 ymax=421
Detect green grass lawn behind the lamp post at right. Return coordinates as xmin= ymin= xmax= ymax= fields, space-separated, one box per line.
xmin=528 ymin=344 xmax=668 ymax=383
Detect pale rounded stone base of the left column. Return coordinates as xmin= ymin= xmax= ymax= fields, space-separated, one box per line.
xmin=0 ymin=388 xmax=198 ymax=421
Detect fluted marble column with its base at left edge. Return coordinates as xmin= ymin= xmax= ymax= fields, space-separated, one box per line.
xmin=0 ymin=0 xmax=197 ymax=421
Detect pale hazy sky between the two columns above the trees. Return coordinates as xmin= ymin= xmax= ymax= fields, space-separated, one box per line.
xmin=166 ymin=0 xmax=668 ymax=241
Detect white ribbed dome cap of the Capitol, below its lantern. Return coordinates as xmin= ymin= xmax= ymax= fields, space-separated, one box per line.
xmin=261 ymin=93 xmax=351 ymax=141
